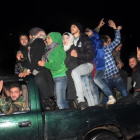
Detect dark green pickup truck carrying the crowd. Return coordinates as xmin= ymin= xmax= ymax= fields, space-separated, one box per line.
xmin=0 ymin=75 xmax=140 ymax=140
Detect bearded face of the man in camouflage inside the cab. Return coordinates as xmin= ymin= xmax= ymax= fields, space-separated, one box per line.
xmin=10 ymin=87 xmax=22 ymax=101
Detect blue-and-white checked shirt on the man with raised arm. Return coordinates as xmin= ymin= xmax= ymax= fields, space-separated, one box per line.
xmin=104 ymin=30 xmax=121 ymax=79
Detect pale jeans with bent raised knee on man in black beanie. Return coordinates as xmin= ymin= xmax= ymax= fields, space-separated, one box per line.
xmin=71 ymin=63 xmax=93 ymax=103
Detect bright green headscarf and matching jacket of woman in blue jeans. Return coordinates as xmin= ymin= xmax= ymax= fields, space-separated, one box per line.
xmin=44 ymin=32 xmax=67 ymax=78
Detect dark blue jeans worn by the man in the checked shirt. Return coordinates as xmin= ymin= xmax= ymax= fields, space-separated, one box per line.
xmin=102 ymin=74 xmax=128 ymax=104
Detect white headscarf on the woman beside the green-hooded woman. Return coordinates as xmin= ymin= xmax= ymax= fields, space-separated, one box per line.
xmin=62 ymin=32 xmax=74 ymax=52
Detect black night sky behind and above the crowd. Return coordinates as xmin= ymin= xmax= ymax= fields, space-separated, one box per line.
xmin=0 ymin=0 xmax=140 ymax=73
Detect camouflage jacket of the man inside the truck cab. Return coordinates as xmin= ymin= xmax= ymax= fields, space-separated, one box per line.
xmin=0 ymin=96 xmax=26 ymax=115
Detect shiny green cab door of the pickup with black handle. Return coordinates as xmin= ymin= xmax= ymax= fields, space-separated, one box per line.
xmin=0 ymin=80 xmax=43 ymax=140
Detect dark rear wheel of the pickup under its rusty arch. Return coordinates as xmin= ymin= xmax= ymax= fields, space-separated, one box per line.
xmin=85 ymin=130 xmax=119 ymax=140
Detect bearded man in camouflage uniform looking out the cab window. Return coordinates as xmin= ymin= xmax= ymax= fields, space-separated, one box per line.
xmin=0 ymin=81 xmax=26 ymax=115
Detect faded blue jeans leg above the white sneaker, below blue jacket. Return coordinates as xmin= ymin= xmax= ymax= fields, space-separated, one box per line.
xmin=93 ymin=70 xmax=112 ymax=97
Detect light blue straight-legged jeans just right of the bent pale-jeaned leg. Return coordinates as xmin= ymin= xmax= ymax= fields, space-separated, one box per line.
xmin=82 ymin=73 xmax=99 ymax=106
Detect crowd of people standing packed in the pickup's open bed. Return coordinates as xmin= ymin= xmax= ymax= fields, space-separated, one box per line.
xmin=0 ymin=19 xmax=140 ymax=113
